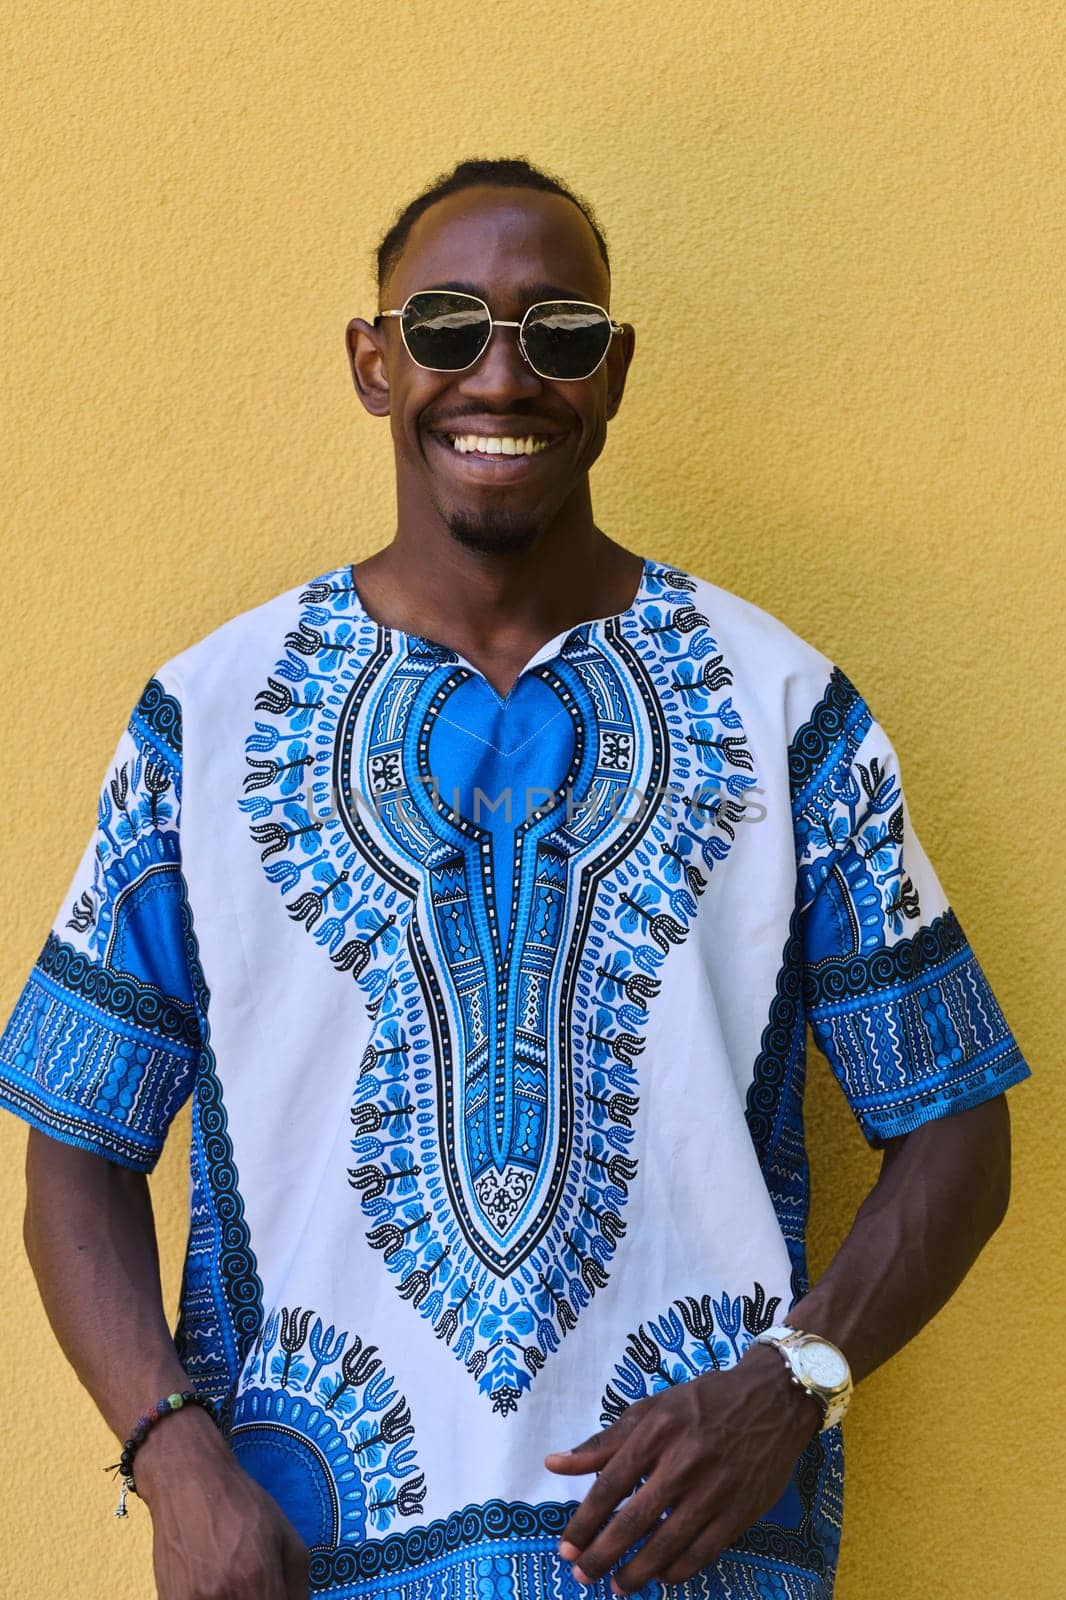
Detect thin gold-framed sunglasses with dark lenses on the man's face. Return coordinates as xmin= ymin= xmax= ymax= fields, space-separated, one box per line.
xmin=375 ymin=290 xmax=621 ymax=382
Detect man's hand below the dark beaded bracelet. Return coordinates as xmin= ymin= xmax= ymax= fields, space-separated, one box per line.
xmin=133 ymin=1406 xmax=307 ymax=1600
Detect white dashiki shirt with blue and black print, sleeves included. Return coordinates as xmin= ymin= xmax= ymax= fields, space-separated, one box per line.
xmin=0 ymin=560 xmax=1029 ymax=1600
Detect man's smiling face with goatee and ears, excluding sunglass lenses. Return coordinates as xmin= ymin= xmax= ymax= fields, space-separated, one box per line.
xmin=347 ymin=187 xmax=634 ymax=552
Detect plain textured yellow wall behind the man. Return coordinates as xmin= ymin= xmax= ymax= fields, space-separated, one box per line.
xmin=0 ymin=0 xmax=1066 ymax=1600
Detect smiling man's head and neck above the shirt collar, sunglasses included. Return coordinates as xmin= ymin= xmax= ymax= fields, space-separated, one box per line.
xmin=347 ymin=172 xmax=642 ymax=696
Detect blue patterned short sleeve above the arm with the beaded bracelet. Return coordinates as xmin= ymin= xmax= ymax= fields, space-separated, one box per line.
xmin=0 ymin=677 xmax=200 ymax=1171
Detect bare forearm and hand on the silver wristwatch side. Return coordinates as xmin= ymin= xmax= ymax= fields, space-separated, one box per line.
xmin=546 ymin=1094 xmax=1010 ymax=1592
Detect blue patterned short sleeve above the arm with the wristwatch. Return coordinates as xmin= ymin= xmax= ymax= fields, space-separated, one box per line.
xmin=789 ymin=666 xmax=1031 ymax=1147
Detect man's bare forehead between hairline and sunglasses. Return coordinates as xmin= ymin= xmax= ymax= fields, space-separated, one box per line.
xmin=386 ymin=186 xmax=610 ymax=314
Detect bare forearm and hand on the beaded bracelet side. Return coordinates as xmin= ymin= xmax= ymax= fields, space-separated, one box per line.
xmin=24 ymin=1130 xmax=307 ymax=1600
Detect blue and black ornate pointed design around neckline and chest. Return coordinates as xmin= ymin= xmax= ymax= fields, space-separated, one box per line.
xmin=242 ymin=565 xmax=755 ymax=1416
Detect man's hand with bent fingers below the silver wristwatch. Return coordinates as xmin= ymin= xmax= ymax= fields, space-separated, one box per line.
xmin=544 ymin=1346 xmax=821 ymax=1594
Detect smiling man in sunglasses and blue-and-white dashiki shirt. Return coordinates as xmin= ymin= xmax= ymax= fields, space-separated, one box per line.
xmin=0 ymin=152 xmax=1029 ymax=1600
